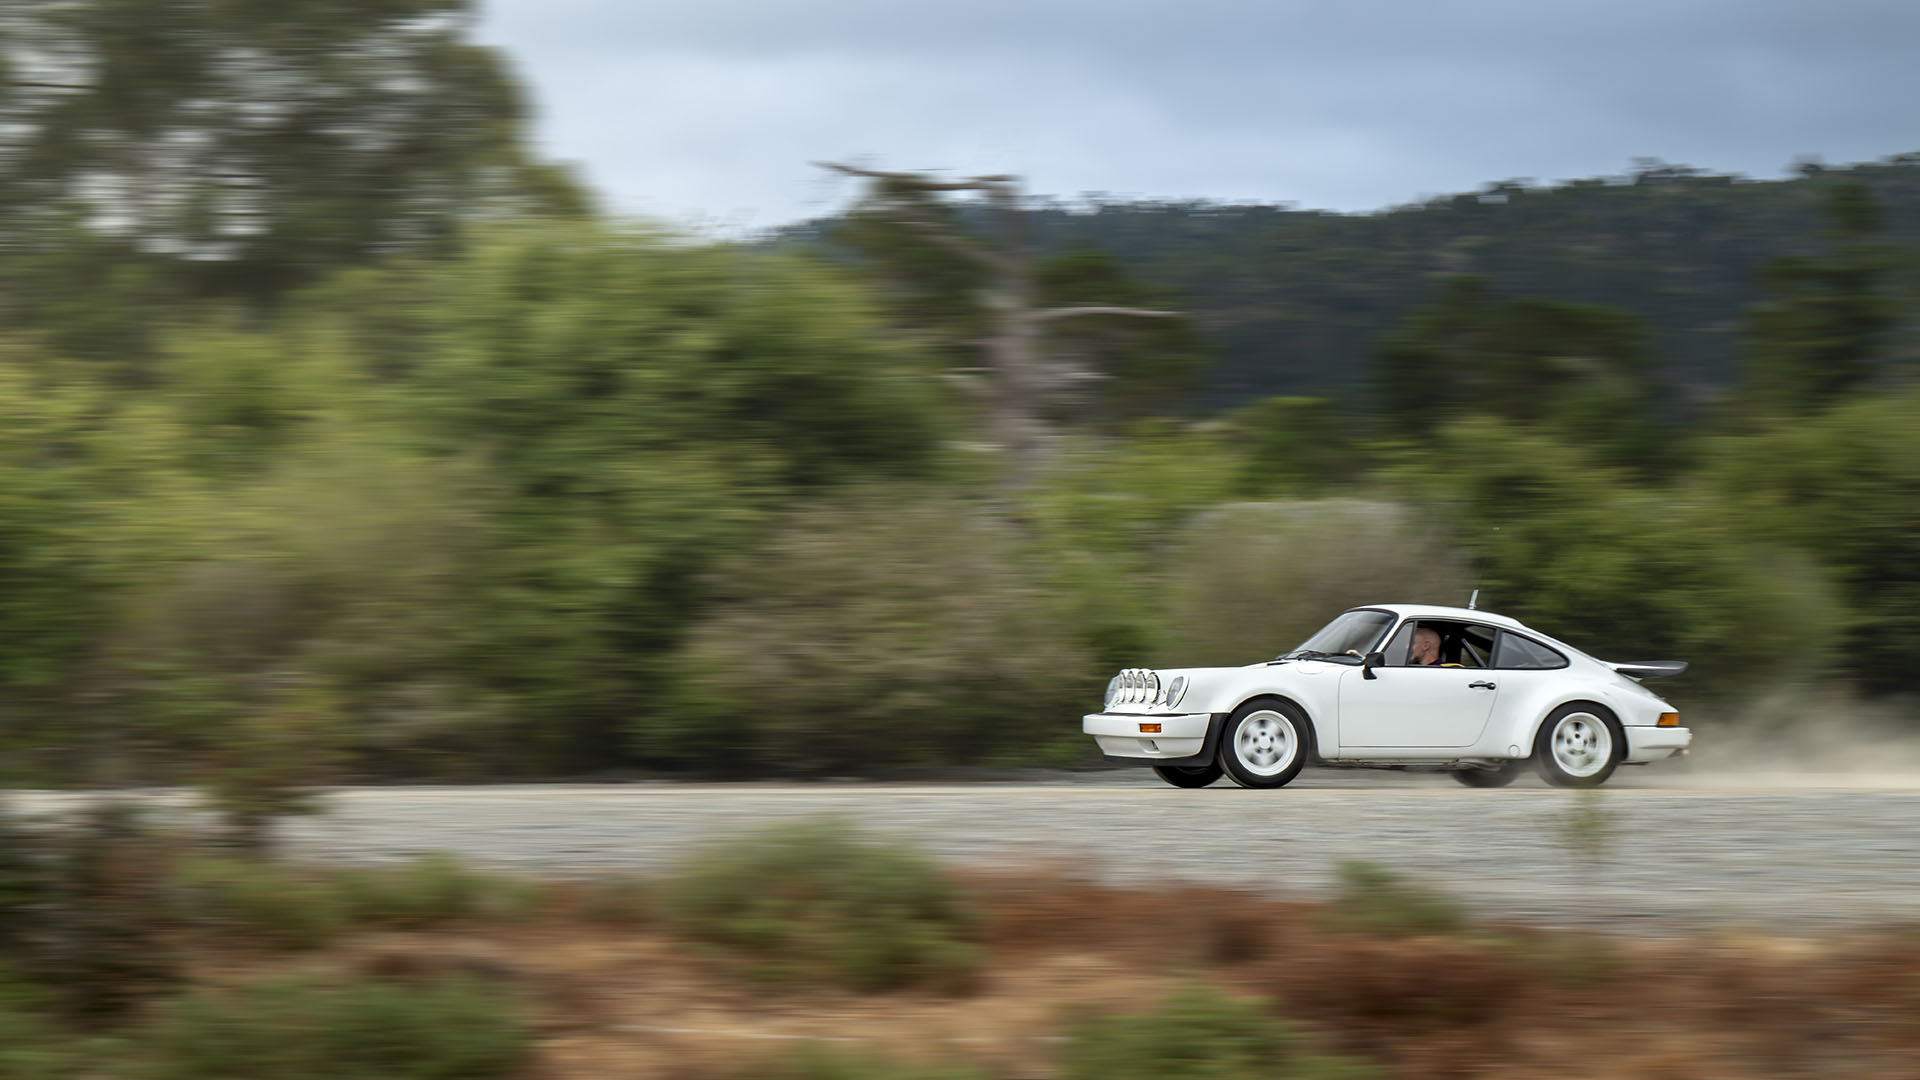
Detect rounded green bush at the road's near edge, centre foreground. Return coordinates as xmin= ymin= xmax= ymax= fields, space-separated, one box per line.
xmin=662 ymin=819 xmax=979 ymax=992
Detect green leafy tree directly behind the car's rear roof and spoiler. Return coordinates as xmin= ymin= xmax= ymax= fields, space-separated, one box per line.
xmin=1400 ymin=419 xmax=1843 ymax=696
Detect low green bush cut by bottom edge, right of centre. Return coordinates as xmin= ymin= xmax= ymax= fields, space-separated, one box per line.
xmin=1060 ymin=988 xmax=1373 ymax=1080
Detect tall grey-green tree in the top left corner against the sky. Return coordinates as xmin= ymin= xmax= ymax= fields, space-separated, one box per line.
xmin=0 ymin=0 xmax=584 ymax=359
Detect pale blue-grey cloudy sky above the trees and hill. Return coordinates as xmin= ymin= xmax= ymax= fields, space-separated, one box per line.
xmin=480 ymin=0 xmax=1920 ymax=231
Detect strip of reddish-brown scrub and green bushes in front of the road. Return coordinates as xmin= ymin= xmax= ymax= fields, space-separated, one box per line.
xmin=0 ymin=807 xmax=1920 ymax=1080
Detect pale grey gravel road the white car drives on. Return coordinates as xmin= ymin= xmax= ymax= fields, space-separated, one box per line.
xmin=255 ymin=771 xmax=1920 ymax=932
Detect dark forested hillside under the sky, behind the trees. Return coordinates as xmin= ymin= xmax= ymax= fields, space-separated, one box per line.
xmin=795 ymin=154 xmax=1920 ymax=407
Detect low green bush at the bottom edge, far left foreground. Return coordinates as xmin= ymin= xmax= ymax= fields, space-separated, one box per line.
xmin=136 ymin=978 xmax=532 ymax=1080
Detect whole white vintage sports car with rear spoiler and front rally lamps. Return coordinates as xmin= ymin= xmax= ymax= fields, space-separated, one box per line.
xmin=1081 ymin=603 xmax=1693 ymax=788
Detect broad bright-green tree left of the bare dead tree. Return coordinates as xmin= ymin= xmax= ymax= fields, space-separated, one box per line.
xmin=320 ymin=227 xmax=950 ymax=767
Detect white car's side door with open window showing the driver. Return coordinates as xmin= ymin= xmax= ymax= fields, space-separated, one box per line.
xmin=1338 ymin=621 xmax=1500 ymax=755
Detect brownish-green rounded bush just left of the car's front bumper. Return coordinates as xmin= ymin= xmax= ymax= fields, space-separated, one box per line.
xmin=664 ymin=488 xmax=1104 ymax=773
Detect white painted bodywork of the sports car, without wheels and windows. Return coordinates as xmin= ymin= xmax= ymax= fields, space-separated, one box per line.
xmin=1083 ymin=603 xmax=1692 ymax=767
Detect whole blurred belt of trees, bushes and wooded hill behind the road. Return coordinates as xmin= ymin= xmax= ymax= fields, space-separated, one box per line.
xmin=0 ymin=0 xmax=1920 ymax=799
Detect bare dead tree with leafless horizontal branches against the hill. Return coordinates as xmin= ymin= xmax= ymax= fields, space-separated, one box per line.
xmin=816 ymin=161 xmax=1181 ymax=490
